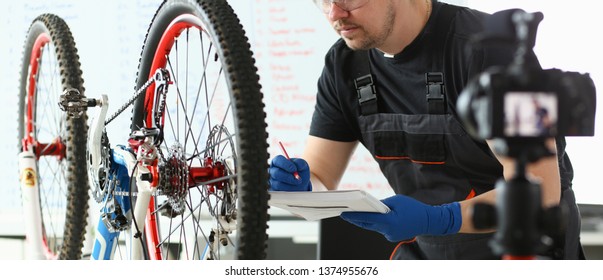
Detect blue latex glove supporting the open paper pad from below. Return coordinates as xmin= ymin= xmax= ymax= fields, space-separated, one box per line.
xmin=341 ymin=194 xmax=462 ymax=242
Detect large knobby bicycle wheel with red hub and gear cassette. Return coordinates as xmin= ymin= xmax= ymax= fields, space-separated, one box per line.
xmin=132 ymin=0 xmax=268 ymax=259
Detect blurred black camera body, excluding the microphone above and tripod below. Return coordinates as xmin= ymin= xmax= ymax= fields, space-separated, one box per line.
xmin=459 ymin=67 xmax=596 ymax=139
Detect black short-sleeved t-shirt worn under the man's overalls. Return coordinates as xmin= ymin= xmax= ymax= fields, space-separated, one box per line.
xmin=310 ymin=1 xmax=573 ymax=189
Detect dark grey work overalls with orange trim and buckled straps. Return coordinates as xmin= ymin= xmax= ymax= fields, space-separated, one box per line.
xmin=355 ymin=4 xmax=502 ymax=259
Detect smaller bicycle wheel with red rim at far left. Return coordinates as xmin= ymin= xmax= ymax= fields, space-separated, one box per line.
xmin=18 ymin=14 xmax=89 ymax=259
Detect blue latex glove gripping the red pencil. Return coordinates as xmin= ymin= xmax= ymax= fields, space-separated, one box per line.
xmin=268 ymin=155 xmax=312 ymax=191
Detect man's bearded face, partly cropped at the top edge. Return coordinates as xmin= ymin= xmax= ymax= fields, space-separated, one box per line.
xmin=327 ymin=0 xmax=396 ymax=50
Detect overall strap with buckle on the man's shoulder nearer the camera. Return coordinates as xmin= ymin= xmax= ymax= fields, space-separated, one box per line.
xmin=425 ymin=3 xmax=460 ymax=115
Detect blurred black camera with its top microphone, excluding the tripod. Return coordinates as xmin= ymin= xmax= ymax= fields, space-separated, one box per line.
xmin=457 ymin=9 xmax=596 ymax=139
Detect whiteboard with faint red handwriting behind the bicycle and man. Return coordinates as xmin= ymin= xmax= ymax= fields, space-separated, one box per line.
xmin=0 ymin=0 xmax=603 ymax=235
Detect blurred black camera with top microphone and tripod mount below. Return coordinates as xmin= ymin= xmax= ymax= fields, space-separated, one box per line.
xmin=457 ymin=9 xmax=596 ymax=259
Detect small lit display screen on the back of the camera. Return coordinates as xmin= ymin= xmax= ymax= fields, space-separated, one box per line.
xmin=504 ymin=92 xmax=558 ymax=137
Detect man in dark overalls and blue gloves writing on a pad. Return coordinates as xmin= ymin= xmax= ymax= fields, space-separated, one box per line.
xmin=270 ymin=0 xmax=581 ymax=259
